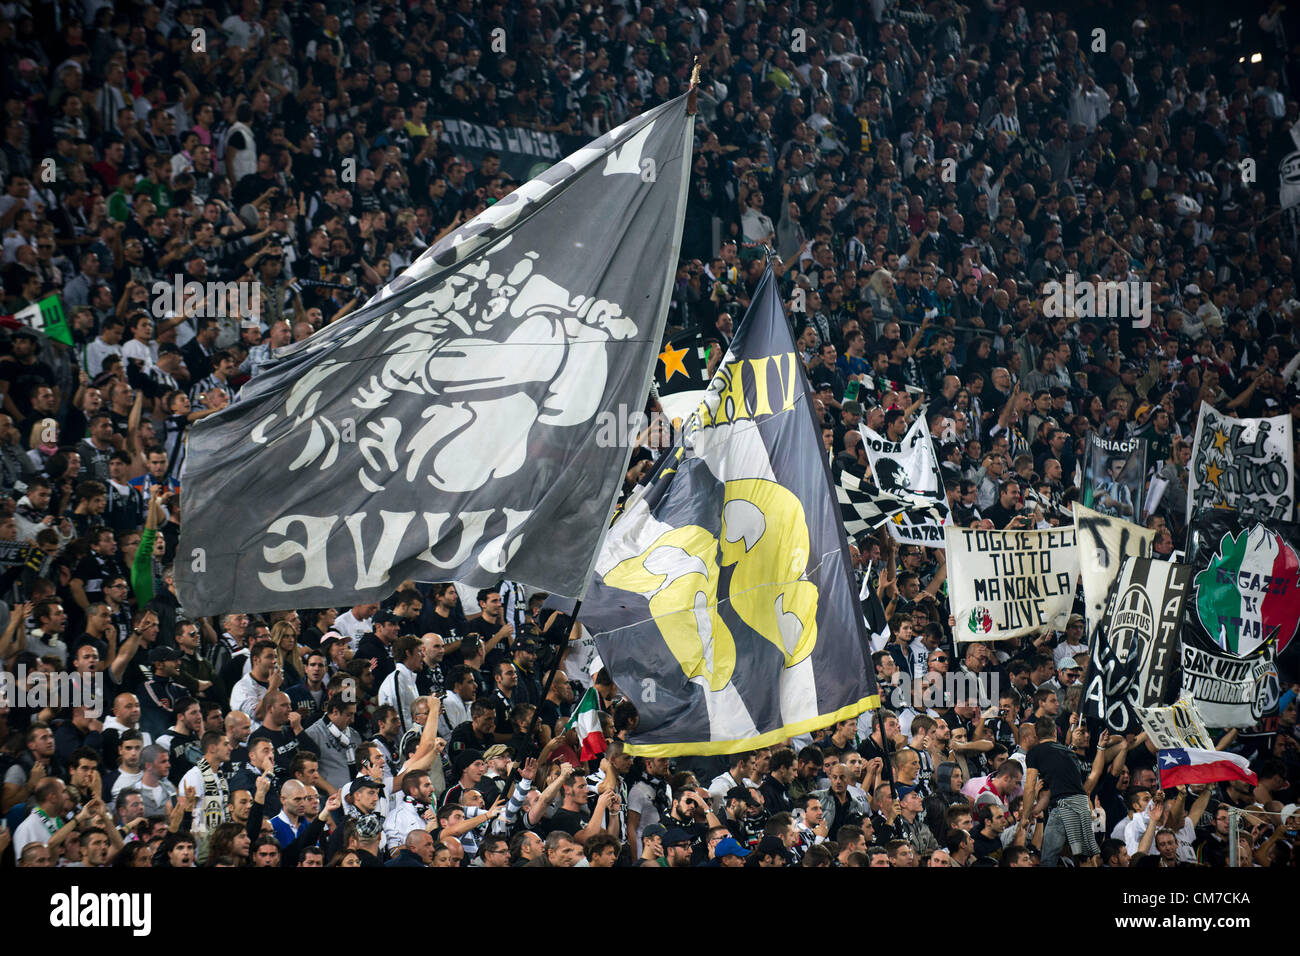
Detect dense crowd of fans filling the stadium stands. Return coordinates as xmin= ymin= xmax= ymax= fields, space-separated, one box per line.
xmin=0 ymin=0 xmax=1300 ymax=866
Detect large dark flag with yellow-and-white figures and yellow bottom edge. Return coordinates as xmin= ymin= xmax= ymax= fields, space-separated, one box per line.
xmin=581 ymin=268 xmax=879 ymax=756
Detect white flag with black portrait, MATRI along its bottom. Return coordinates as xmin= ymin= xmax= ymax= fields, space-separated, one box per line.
xmin=861 ymin=407 xmax=949 ymax=548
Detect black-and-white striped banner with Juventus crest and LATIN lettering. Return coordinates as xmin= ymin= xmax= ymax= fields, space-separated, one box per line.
xmin=1083 ymin=558 xmax=1192 ymax=734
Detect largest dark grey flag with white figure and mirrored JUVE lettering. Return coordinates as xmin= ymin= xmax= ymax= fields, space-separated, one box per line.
xmin=177 ymin=96 xmax=694 ymax=615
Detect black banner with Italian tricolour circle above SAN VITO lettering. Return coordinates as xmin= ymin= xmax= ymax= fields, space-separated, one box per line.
xmin=1183 ymin=510 xmax=1300 ymax=727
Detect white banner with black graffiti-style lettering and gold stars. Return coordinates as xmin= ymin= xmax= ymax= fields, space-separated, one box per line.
xmin=1187 ymin=402 xmax=1296 ymax=525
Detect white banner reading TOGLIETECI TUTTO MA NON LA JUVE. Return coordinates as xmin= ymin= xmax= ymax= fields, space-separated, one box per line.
xmin=944 ymin=525 xmax=1079 ymax=641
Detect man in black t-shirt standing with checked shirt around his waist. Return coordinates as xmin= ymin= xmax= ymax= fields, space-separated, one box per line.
xmin=1024 ymin=717 xmax=1101 ymax=866
